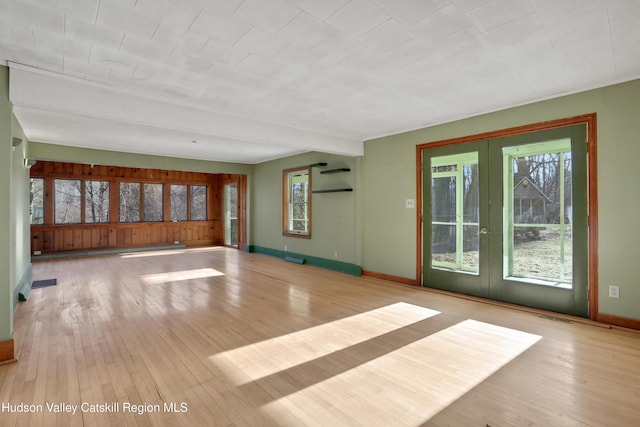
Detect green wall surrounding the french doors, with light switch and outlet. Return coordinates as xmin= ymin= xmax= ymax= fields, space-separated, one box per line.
xmin=362 ymin=80 xmax=640 ymax=319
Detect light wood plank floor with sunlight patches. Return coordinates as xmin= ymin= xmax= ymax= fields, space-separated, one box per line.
xmin=0 ymin=248 xmax=640 ymax=427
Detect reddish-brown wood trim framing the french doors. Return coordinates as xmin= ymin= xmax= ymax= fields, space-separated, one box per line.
xmin=416 ymin=113 xmax=598 ymax=320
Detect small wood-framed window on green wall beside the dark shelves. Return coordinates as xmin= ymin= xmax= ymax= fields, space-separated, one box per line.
xmin=282 ymin=167 xmax=311 ymax=237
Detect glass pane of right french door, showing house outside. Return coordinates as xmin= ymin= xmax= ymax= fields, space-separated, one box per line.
xmin=503 ymin=138 xmax=572 ymax=289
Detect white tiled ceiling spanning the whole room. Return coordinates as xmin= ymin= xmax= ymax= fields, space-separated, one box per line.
xmin=0 ymin=0 xmax=640 ymax=163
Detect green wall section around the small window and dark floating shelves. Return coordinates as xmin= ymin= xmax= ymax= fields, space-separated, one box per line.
xmin=250 ymin=153 xmax=361 ymax=266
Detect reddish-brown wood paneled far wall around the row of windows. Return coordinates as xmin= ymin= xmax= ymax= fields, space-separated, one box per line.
xmin=31 ymin=161 xmax=246 ymax=253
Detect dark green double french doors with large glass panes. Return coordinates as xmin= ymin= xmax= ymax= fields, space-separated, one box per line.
xmin=422 ymin=125 xmax=588 ymax=317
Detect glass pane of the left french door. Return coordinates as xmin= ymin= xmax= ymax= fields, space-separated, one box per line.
xmin=431 ymin=152 xmax=480 ymax=273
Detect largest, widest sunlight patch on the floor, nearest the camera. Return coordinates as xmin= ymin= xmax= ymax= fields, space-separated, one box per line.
xmin=262 ymin=320 xmax=542 ymax=426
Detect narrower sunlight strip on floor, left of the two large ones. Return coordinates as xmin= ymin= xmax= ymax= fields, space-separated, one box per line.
xmin=209 ymin=302 xmax=440 ymax=384
